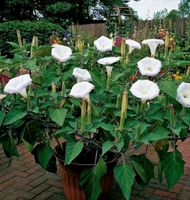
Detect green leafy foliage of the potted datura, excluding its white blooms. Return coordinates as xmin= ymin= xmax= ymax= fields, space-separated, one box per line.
xmin=0 ymin=25 xmax=190 ymax=200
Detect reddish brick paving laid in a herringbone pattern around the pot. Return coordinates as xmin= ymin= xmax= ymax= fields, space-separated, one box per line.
xmin=0 ymin=139 xmax=190 ymax=200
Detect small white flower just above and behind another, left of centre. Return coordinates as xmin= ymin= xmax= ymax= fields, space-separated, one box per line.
xmin=73 ymin=67 xmax=92 ymax=82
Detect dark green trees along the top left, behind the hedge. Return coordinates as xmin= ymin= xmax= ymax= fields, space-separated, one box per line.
xmin=0 ymin=0 xmax=138 ymax=24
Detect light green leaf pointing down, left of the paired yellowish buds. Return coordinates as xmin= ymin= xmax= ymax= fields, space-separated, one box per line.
xmin=49 ymin=108 xmax=67 ymax=126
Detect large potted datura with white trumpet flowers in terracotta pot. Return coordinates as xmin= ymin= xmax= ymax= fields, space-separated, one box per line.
xmin=0 ymin=32 xmax=190 ymax=200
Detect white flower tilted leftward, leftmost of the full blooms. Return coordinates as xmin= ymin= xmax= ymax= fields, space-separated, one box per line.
xmin=4 ymin=74 xmax=32 ymax=98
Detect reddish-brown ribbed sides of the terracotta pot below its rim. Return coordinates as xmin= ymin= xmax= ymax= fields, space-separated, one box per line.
xmin=60 ymin=162 xmax=113 ymax=200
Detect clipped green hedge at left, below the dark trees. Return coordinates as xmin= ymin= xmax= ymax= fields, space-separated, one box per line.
xmin=0 ymin=20 xmax=64 ymax=55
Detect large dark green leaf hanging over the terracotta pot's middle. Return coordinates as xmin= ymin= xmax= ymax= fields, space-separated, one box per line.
xmin=80 ymin=159 xmax=107 ymax=200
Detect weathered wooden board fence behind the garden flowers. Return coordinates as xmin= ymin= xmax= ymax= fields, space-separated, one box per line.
xmin=73 ymin=19 xmax=190 ymax=41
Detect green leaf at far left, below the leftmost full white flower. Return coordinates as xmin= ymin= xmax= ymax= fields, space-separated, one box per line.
xmin=3 ymin=109 xmax=27 ymax=125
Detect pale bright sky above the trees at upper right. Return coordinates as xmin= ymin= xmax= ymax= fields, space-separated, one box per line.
xmin=129 ymin=0 xmax=180 ymax=19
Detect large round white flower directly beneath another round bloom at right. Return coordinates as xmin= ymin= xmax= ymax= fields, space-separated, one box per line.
xmin=130 ymin=80 xmax=160 ymax=102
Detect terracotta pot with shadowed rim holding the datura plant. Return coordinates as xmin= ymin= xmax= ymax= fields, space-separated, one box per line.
xmin=56 ymin=145 xmax=118 ymax=200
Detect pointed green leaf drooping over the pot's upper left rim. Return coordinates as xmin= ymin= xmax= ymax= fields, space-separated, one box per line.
xmin=65 ymin=141 xmax=84 ymax=165
